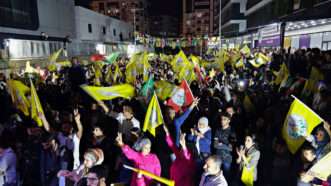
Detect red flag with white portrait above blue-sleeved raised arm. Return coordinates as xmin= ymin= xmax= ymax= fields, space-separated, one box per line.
xmin=167 ymin=80 xmax=194 ymax=112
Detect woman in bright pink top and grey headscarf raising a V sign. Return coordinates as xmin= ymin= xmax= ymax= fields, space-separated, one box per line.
xmin=116 ymin=133 xmax=161 ymax=186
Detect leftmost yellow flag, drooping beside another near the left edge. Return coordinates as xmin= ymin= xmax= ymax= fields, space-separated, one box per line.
xmin=7 ymin=80 xmax=30 ymax=116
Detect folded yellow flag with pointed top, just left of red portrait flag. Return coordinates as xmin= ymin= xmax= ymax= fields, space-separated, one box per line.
xmin=143 ymin=93 xmax=164 ymax=136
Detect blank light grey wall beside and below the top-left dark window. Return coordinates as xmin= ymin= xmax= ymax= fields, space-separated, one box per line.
xmin=0 ymin=0 xmax=76 ymax=38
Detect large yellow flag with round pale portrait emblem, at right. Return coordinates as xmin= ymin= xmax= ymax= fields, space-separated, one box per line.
xmin=282 ymin=98 xmax=323 ymax=154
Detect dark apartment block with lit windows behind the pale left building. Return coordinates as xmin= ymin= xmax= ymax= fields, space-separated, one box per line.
xmin=91 ymin=0 xmax=150 ymax=33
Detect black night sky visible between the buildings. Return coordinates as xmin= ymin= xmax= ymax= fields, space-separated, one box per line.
xmin=75 ymin=0 xmax=182 ymax=16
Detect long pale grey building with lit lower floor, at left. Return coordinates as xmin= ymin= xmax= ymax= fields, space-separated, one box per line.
xmin=0 ymin=0 xmax=133 ymax=66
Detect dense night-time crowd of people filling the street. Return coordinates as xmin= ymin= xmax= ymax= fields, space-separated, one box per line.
xmin=0 ymin=46 xmax=331 ymax=186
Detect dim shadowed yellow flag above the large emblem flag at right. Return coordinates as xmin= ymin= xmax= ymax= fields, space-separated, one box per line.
xmin=302 ymin=67 xmax=324 ymax=95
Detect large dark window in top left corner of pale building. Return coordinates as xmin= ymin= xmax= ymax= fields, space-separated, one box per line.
xmin=0 ymin=0 xmax=39 ymax=30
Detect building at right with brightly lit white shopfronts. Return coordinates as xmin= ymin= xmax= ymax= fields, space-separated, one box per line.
xmin=222 ymin=0 xmax=331 ymax=50
